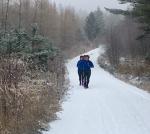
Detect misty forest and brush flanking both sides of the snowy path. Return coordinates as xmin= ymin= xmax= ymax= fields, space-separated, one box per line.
xmin=0 ymin=0 xmax=150 ymax=134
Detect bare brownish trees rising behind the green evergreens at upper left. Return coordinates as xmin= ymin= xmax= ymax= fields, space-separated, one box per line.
xmin=0 ymin=0 xmax=88 ymax=55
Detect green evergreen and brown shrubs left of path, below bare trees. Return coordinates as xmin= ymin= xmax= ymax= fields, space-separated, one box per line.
xmin=0 ymin=27 xmax=65 ymax=134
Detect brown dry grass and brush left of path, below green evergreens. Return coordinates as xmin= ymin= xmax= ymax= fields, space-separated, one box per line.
xmin=0 ymin=57 xmax=66 ymax=134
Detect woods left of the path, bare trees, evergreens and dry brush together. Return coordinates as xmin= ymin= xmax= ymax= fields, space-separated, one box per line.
xmin=0 ymin=0 xmax=87 ymax=134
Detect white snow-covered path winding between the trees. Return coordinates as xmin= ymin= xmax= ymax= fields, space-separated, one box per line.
xmin=43 ymin=47 xmax=150 ymax=134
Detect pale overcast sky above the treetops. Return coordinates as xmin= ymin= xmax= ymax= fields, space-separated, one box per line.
xmin=50 ymin=0 xmax=127 ymax=12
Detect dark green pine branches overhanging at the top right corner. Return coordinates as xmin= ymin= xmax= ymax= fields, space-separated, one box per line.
xmin=106 ymin=0 xmax=150 ymax=35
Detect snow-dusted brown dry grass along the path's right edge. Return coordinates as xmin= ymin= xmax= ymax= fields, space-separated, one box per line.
xmin=98 ymin=54 xmax=150 ymax=92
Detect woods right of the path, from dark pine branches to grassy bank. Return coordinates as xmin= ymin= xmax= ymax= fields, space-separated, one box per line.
xmin=99 ymin=0 xmax=150 ymax=91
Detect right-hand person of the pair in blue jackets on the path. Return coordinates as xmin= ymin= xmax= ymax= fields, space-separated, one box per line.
xmin=84 ymin=55 xmax=94 ymax=88
